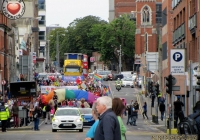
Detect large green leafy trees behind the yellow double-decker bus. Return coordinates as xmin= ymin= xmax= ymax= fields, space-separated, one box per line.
xmin=49 ymin=15 xmax=135 ymax=69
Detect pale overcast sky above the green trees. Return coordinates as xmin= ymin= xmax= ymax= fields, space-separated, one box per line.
xmin=46 ymin=0 xmax=109 ymax=27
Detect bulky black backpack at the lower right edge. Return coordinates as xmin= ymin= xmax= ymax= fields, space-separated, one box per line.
xmin=177 ymin=111 xmax=200 ymax=135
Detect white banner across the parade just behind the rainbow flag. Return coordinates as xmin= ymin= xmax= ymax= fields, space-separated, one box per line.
xmin=40 ymin=86 xmax=78 ymax=94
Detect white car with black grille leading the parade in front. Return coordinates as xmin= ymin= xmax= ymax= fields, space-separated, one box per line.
xmin=52 ymin=107 xmax=83 ymax=132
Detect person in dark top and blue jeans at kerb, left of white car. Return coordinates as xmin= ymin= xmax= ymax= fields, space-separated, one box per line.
xmin=33 ymin=106 xmax=42 ymax=131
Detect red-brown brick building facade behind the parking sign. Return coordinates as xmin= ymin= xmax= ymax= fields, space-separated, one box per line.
xmin=162 ymin=0 xmax=200 ymax=115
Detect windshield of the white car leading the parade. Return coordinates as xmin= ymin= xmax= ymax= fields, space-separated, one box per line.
xmin=55 ymin=109 xmax=80 ymax=116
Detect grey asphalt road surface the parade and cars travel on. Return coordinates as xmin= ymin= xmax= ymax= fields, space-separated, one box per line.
xmin=0 ymin=81 xmax=164 ymax=140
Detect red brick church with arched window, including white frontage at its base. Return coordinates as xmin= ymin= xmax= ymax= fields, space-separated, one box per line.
xmin=114 ymin=0 xmax=162 ymax=88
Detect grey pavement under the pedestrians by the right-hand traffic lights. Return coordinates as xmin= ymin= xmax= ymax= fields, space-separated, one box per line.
xmin=138 ymin=93 xmax=167 ymax=133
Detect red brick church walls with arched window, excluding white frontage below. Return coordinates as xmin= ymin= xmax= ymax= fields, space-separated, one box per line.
xmin=114 ymin=0 xmax=162 ymax=76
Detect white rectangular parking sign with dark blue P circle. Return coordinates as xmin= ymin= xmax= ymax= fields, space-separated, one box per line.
xmin=170 ymin=49 xmax=185 ymax=75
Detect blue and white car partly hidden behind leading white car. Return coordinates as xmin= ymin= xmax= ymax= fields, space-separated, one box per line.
xmin=79 ymin=108 xmax=95 ymax=126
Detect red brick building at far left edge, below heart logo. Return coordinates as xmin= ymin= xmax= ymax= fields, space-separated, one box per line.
xmin=0 ymin=12 xmax=11 ymax=80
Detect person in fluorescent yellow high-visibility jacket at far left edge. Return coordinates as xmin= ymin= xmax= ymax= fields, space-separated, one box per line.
xmin=0 ymin=102 xmax=10 ymax=132
